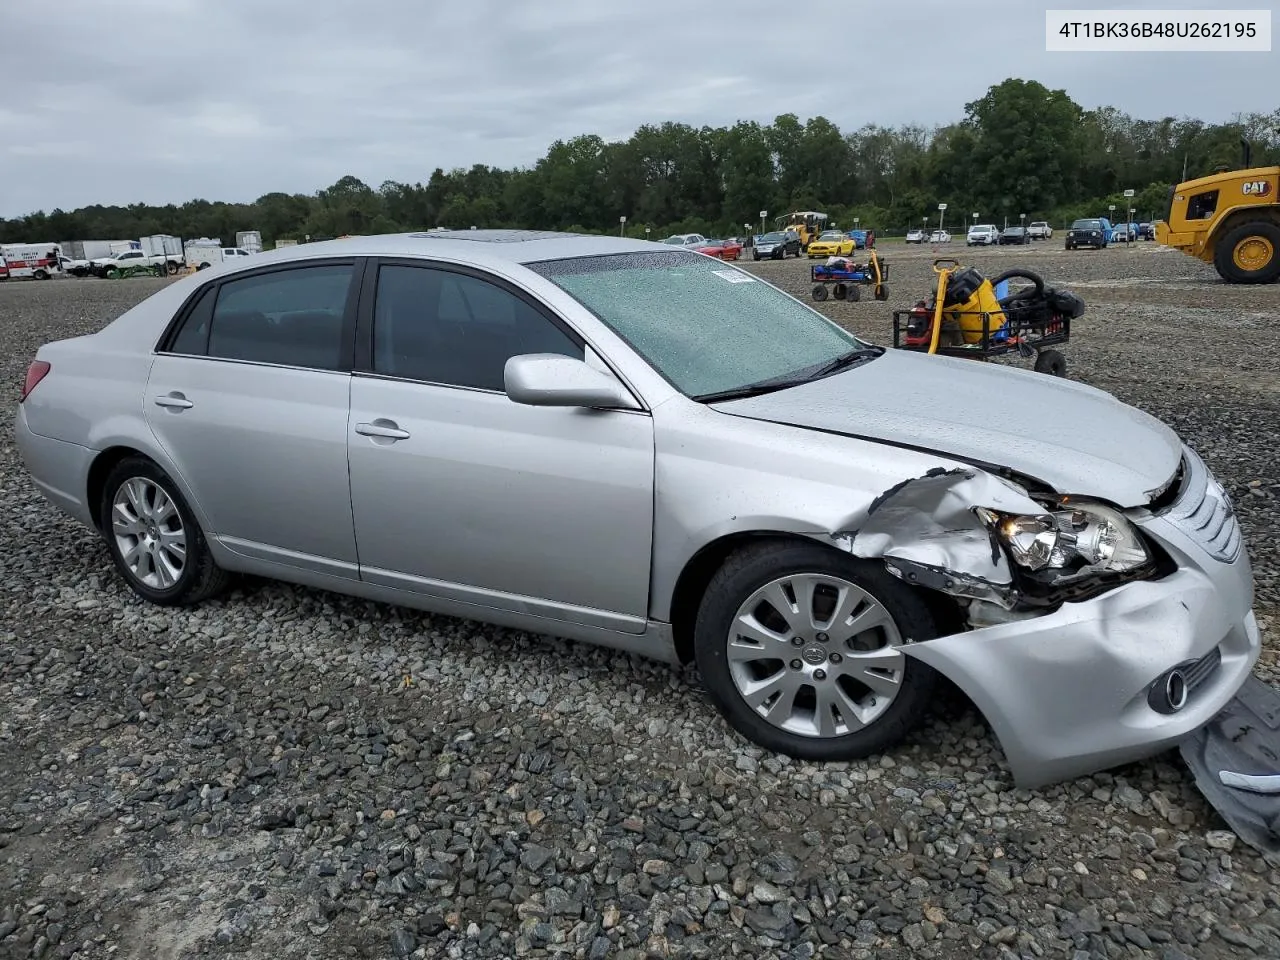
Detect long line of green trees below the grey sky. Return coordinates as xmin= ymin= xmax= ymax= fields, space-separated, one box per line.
xmin=0 ymin=79 xmax=1280 ymax=246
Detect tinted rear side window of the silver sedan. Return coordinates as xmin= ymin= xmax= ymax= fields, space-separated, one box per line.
xmin=170 ymin=264 xmax=355 ymax=370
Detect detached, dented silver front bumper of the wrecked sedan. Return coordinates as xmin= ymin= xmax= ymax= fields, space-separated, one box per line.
xmin=904 ymin=504 xmax=1261 ymax=787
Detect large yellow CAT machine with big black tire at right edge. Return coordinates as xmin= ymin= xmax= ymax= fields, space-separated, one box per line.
xmin=1156 ymin=141 xmax=1280 ymax=283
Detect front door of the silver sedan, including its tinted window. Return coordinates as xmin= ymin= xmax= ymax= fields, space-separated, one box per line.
xmin=348 ymin=262 xmax=654 ymax=632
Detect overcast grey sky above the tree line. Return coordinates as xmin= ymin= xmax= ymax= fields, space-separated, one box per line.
xmin=0 ymin=0 xmax=1280 ymax=216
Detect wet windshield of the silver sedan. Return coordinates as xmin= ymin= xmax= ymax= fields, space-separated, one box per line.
xmin=527 ymin=251 xmax=868 ymax=397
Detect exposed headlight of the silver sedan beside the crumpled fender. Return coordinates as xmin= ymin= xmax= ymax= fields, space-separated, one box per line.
xmin=979 ymin=498 xmax=1152 ymax=582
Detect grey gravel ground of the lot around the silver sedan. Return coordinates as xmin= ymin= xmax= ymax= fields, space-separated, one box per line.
xmin=0 ymin=241 xmax=1280 ymax=960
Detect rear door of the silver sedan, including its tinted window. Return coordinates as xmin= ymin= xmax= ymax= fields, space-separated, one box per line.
xmin=146 ymin=259 xmax=360 ymax=579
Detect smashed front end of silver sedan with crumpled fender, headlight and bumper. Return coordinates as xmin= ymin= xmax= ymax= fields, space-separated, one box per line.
xmin=835 ymin=465 xmax=1260 ymax=814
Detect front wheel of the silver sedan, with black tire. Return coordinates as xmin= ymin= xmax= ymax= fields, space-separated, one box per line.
xmin=694 ymin=541 xmax=937 ymax=760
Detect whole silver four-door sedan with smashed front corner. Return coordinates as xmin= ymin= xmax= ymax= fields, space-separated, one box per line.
xmin=17 ymin=230 xmax=1258 ymax=786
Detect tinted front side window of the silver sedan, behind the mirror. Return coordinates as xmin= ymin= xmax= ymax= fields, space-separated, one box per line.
xmin=372 ymin=264 xmax=585 ymax=392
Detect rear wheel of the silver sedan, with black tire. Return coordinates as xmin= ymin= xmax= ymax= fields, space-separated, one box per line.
xmin=99 ymin=457 xmax=232 ymax=607
